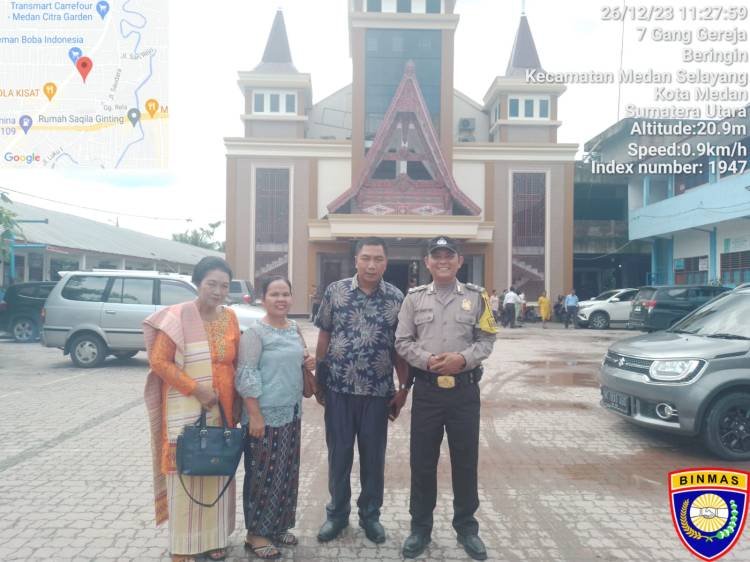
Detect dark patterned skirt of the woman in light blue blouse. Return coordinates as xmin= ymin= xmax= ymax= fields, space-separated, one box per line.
xmin=242 ymin=417 xmax=301 ymax=537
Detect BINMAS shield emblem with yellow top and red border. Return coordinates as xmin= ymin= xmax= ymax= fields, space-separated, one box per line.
xmin=669 ymin=468 xmax=750 ymax=560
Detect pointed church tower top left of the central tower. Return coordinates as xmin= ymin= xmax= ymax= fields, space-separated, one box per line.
xmin=238 ymin=10 xmax=312 ymax=138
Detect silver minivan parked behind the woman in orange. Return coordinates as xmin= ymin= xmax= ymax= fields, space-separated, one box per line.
xmin=42 ymin=270 xmax=197 ymax=368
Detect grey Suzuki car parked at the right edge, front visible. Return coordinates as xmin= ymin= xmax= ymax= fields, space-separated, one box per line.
xmin=600 ymin=288 xmax=750 ymax=461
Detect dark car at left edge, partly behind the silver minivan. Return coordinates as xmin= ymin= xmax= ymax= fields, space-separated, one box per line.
xmin=0 ymin=281 xmax=56 ymax=342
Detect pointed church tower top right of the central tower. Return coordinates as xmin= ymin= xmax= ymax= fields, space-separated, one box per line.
xmin=484 ymin=13 xmax=565 ymax=143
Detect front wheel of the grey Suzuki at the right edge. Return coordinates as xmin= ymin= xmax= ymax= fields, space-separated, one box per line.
xmin=703 ymin=392 xmax=750 ymax=461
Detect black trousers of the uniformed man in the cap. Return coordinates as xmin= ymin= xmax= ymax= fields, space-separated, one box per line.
xmin=409 ymin=379 xmax=479 ymax=536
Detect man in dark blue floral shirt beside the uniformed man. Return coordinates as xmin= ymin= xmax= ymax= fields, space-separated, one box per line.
xmin=315 ymin=238 xmax=409 ymax=543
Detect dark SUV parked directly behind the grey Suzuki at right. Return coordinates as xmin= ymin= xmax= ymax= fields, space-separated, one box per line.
xmin=628 ymin=285 xmax=731 ymax=331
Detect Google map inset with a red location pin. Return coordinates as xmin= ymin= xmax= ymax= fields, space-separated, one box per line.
xmin=0 ymin=0 xmax=169 ymax=169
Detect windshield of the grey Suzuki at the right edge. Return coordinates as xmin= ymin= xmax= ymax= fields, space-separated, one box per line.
xmin=669 ymin=292 xmax=750 ymax=339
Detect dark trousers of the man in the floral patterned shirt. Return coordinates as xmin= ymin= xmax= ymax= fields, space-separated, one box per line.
xmin=325 ymin=390 xmax=388 ymax=522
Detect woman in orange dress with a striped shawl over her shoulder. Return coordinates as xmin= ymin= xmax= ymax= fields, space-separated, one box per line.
xmin=144 ymin=258 xmax=240 ymax=562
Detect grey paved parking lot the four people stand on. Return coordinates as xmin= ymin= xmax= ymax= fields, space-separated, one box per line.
xmin=0 ymin=324 xmax=750 ymax=562
